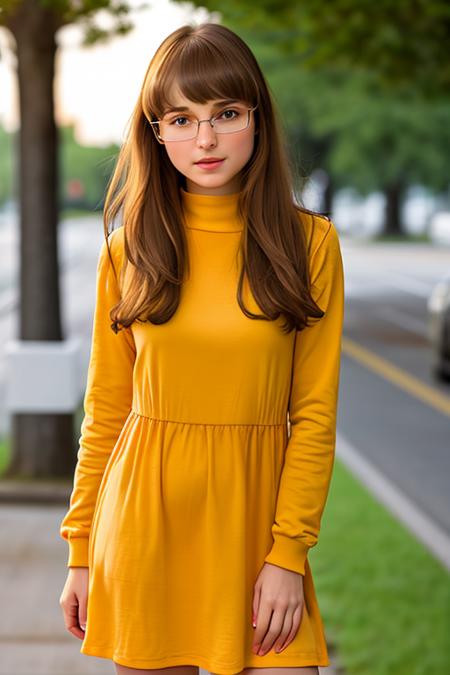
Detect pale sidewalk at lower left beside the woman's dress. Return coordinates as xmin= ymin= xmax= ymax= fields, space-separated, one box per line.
xmin=0 ymin=488 xmax=336 ymax=675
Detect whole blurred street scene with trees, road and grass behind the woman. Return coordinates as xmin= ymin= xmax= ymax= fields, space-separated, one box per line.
xmin=0 ymin=0 xmax=450 ymax=675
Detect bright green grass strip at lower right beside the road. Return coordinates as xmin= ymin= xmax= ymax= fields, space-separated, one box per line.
xmin=309 ymin=459 xmax=450 ymax=675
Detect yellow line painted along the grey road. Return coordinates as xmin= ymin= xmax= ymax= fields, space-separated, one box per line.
xmin=342 ymin=336 xmax=450 ymax=417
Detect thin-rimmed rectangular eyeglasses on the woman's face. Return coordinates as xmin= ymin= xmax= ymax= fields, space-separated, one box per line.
xmin=150 ymin=105 xmax=258 ymax=141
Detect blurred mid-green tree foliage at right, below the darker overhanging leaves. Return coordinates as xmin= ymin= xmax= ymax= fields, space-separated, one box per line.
xmin=300 ymin=71 xmax=450 ymax=193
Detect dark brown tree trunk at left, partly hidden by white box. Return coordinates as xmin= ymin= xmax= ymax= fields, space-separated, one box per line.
xmin=5 ymin=0 xmax=76 ymax=478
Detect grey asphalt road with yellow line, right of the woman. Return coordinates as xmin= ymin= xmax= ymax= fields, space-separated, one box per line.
xmin=338 ymin=242 xmax=450 ymax=535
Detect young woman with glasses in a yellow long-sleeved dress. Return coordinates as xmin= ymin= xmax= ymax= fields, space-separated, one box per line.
xmin=60 ymin=23 xmax=344 ymax=675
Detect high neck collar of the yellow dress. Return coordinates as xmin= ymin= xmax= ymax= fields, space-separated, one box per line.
xmin=180 ymin=187 xmax=243 ymax=232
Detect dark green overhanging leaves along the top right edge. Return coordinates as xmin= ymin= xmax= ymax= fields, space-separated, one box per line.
xmin=182 ymin=0 xmax=450 ymax=97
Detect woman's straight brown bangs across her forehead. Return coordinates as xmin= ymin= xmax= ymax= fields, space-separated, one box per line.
xmin=144 ymin=37 xmax=258 ymax=118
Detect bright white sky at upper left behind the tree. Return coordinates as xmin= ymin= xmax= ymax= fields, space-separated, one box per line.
xmin=0 ymin=0 xmax=220 ymax=146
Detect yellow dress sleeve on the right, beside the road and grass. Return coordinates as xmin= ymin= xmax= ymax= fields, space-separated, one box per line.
xmin=265 ymin=221 xmax=344 ymax=575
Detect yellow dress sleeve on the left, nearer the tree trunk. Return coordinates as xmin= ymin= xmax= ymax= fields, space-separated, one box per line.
xmin=60 ymin=228 xmax=136 ymax=567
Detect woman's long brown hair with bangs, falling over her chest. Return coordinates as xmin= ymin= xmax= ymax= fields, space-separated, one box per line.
xmin=103 ymin=23 xmax=324 ymax=332
